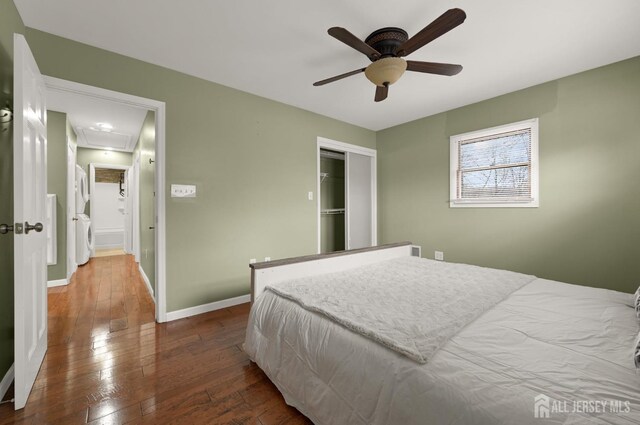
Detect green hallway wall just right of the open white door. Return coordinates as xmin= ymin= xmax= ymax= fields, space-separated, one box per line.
xmin=47 ymin=111 xmax=67 ymax=281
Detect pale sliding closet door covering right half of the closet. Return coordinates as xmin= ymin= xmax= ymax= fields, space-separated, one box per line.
xmin=345 ymin=152 xmax=375 ymax=249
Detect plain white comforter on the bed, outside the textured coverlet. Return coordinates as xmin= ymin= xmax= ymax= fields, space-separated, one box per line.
xmin=245 ymin=272 xmax=640 ymax=425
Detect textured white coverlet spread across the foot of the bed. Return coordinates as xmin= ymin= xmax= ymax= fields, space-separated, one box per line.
xmin=267 ymin=257 xmax=535 ymax=363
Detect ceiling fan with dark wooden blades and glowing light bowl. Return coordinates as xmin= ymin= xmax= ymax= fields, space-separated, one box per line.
xmin=313 ymin=9 xmax=467 ymax=102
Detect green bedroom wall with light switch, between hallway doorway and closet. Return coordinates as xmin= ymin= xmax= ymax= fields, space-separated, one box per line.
xmin=27 ymin=28 xmax=376 ymax=311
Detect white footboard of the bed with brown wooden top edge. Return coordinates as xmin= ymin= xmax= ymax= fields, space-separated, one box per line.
xmin=249 ymin=242 xmax=416 ymax=303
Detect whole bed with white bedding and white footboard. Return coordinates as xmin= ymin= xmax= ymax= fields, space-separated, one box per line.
xmin=244 ymin=242 xmax=640 ymax=425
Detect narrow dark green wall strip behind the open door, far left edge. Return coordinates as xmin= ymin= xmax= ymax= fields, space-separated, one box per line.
xmin=0 ymin=0 xmax=25 ymax=388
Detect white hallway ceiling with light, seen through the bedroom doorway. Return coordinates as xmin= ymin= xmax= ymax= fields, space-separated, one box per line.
xmin=47 ymin=88 xmax=147 ymax=152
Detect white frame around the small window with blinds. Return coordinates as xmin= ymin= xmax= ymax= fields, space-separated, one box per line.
xmin=449 ymin=118 xmax=540 ymax=208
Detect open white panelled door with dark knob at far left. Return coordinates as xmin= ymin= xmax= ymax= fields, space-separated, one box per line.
xmin=13 ymin=34 xmax=47 ymax=410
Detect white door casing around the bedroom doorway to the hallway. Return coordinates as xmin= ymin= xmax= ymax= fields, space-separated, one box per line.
xmin=44 ymin=76 xmax=167 ymax=322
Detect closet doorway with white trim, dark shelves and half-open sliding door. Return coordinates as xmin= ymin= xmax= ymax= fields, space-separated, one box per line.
xmin=316 ymin=137 xmax=377 ymax=253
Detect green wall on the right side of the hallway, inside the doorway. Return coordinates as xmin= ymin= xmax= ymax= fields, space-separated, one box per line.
xmin=134 ymin=111 xmax=156 ymax=294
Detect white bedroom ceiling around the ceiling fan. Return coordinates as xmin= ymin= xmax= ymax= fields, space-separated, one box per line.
xmin=14 ymin=0 xmax=640 ymax=130
